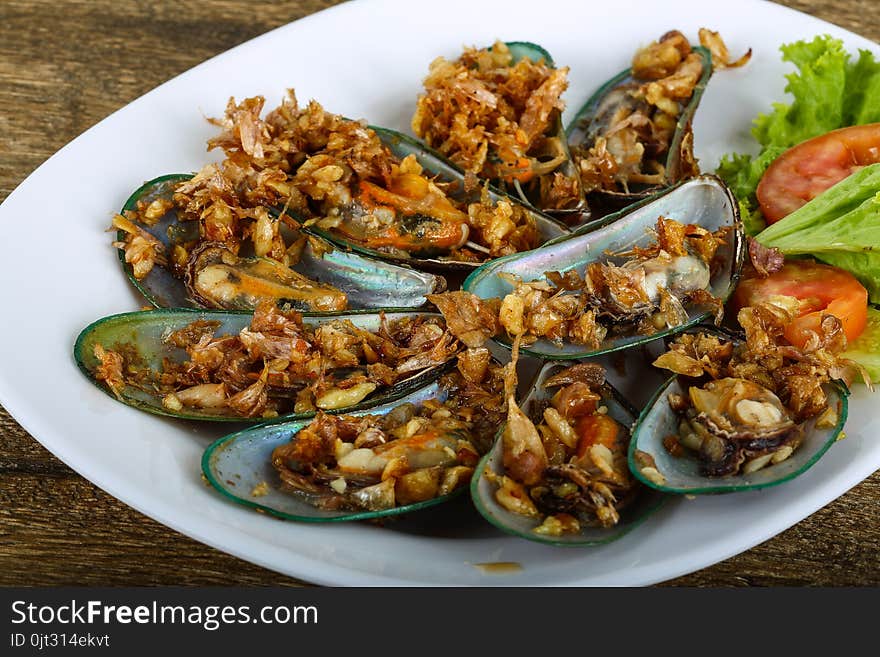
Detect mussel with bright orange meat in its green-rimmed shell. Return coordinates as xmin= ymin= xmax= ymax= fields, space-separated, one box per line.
xmin=305 ymin=126 xmax=570 ymax=272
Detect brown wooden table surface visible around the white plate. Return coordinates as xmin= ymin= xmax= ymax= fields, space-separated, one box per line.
xmin=0 ymin=0 xmax=880 ymax=586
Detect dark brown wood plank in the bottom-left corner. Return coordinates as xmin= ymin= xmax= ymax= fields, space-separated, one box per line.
xmin=0 ymin=471 xmax=306 ymax=586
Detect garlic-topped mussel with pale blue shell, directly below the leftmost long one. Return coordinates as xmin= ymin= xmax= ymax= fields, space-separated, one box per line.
xmin=202 ymin=348 xmax=504 ymax=522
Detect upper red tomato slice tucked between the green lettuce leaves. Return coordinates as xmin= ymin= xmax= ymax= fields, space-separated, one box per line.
xmin=756 ymin=123 xmax=880 ymax=224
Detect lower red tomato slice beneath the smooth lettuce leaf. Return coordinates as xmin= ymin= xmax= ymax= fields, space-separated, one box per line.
xmin=733 ymin=260 xmax=868 ymax=347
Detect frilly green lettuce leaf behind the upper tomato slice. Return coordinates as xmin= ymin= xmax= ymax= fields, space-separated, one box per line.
xmin=716 ymin=35 xmax=880 ymax=235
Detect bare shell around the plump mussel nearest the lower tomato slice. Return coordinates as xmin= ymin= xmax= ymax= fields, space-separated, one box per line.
xmin=628 ymin=327 xmax=849 ymax=495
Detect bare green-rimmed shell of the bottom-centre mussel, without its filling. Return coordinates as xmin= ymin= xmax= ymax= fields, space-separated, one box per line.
xmin=471 ymin=363 xmax=669 ymax=547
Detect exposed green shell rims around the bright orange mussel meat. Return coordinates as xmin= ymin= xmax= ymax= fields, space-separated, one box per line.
xmin=305 ymin=126 xmax=571 ymax=272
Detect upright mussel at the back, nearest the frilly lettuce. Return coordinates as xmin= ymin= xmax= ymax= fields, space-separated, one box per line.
xmin=566 ymin=31 xmax=712 ymax=223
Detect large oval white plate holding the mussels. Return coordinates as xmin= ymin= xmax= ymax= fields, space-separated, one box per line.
xmin=0 ymin=0 xmax=880 ymax=585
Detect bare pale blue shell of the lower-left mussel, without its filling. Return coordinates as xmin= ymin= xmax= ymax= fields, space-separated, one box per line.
xmin=202 ymin=382 xmax=466 ymax=522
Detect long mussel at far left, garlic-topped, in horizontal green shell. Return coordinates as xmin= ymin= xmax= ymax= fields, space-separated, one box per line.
xmin=74 ymin=301 xmax=459 ymax=422
